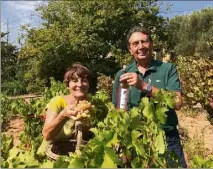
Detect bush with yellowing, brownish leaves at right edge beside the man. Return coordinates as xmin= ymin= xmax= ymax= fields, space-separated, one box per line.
xmin=177 ymin=56 xmax=213 ymax=106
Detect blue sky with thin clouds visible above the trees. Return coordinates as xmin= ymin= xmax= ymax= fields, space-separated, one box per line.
xmin=1 ymin=0 xmax=213 ymax=46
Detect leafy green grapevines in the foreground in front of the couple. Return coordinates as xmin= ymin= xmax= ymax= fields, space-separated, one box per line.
xmin=1 ymin=79 xmax=212 ymax=168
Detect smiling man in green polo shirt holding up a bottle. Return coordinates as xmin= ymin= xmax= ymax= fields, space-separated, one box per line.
xmin=112 ymin=26 xmax=187 ymax=168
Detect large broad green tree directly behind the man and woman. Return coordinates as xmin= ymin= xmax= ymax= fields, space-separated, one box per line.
xmin=19 ymin=0 xmax=166 ymax=92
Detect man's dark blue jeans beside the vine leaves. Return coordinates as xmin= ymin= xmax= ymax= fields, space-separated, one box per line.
xmin=166 ymin=129 xmax=187 ymax=168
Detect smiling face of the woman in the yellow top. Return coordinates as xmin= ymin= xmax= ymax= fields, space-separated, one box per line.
xmin=68 ymin=76 xmax=89 ymax=99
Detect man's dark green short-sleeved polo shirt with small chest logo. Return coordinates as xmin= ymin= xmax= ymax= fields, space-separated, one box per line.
xmin=112 ymin=60 xmax=182 ymax=131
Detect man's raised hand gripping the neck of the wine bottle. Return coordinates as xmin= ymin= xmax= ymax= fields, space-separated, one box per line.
xmin=120 ymin=72 xmax=144 ymax=90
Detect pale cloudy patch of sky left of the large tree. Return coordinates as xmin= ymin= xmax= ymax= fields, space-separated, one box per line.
xmin=1 ymin=1 xmax=48 ymax=45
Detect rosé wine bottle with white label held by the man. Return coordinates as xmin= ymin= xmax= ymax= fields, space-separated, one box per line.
xmin=115 ymin=65 xmax=129 ymax=111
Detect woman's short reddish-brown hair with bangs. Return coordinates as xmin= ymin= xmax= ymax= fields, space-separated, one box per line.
xmin=64 ymin=62 xmax=92 ymax=87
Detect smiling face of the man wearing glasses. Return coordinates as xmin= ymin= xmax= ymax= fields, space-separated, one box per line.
xmin=129 ymin=32 xmax=153 ymax=61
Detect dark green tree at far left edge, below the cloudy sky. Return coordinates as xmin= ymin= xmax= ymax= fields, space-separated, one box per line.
xmin=1 ymin=32 xmax=26 ymax=95
